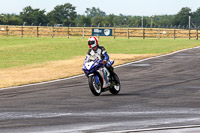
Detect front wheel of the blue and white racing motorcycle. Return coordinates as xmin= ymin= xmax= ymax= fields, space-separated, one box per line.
xmin=88 ymin=75 xmax=101 ymax=96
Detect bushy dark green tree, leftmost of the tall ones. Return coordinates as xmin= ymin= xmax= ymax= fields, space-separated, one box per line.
xmin=20 ymin=6 xmax=48 ymax=25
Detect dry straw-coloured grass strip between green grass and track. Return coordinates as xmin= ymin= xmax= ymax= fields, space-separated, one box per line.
xmin=0 ymin=54 xmax=155 ymax=88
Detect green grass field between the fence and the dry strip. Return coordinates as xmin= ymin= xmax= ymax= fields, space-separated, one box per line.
xmin=0 ymin=37 xmax=200 ymax=68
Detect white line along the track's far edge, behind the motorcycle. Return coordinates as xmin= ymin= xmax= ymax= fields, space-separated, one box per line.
xmin=0 ymin=46 xmax=200 ymax=91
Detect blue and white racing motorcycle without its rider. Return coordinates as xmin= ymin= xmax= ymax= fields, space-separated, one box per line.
xmin=82 ymin=58 xmax=121 ymax=96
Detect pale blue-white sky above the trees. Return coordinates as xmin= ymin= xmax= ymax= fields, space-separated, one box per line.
xmin=0 ymin=0 xmax=200 ymax=16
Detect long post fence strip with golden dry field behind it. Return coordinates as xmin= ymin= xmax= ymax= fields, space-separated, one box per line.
xmin=0 ymin=25 xmax=200 ymax=40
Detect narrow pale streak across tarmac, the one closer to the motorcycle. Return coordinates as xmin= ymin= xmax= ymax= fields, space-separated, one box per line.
xmin=0 ymin=108 xmax=200 ymax=120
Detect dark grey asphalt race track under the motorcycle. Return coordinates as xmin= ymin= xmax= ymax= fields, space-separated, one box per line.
xmin=0 ymin=47 xmax=200 ymax=133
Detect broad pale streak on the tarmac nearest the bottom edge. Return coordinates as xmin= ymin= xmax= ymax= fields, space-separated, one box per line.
xmin=1 ymin=118 xmax=200 ymax=133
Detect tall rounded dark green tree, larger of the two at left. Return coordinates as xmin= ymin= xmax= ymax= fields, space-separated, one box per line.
xmin=47 ymin=3 xmax=77 ymax=25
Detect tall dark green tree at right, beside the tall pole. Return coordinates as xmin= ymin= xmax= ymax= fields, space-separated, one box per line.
xmin=174 ymin=7 xmax=191 ymax=25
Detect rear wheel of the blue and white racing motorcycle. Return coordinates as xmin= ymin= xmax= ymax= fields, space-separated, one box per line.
xmin=109 ymin=73 xmax=121 ymax=95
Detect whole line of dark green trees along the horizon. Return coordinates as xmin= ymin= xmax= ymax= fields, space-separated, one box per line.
xmin=0 ymin=3 xmax=200 ymax=28
